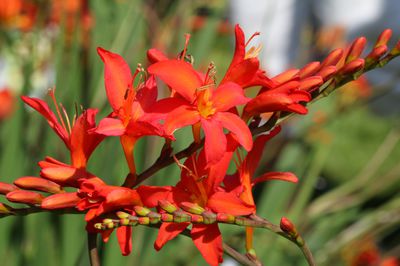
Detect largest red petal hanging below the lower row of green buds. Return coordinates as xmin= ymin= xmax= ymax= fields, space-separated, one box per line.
xmin=191 ymin=224 xmax=223 ymax=266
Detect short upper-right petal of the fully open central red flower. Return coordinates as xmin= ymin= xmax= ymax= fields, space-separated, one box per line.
xmin=212 ymin=82 xmax=250 ymax=111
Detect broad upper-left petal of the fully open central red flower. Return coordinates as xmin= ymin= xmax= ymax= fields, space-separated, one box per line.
xmin=148 ymin=60 xmax=203 ymax=102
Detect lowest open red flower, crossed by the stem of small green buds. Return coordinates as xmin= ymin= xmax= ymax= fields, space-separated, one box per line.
xmin=138 ymin=151 xmax=254 ymax=265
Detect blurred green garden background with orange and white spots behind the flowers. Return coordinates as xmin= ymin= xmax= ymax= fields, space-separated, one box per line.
xmin=0 ymin=0 xmax=400 ymax=266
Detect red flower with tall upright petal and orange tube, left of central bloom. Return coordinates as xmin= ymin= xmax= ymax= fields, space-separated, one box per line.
xmin=96 ymin=47 xmax=171 ymax=174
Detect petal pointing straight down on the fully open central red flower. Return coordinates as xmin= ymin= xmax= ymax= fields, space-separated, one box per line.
xmin=201 ymin=118 xmax=226 ymax=165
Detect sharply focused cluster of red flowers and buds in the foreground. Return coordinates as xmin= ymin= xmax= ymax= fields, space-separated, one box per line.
xmin=0 ymin=26 xmax=400 ymax=265
